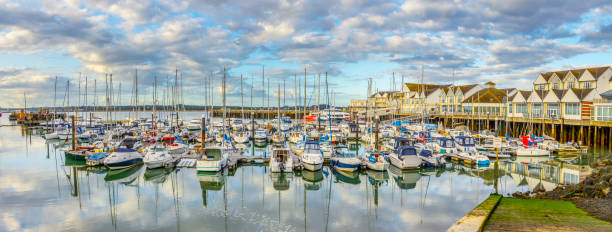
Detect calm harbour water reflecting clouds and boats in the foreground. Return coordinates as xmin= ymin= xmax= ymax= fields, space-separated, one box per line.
xmin=0 ymin=113 xmax=599 ymax=231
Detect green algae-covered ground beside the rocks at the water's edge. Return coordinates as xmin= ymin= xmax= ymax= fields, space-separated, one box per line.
xmin=485 ymin=198 xmax=612 ymax=231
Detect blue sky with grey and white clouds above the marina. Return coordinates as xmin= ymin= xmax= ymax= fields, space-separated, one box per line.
xmin=0 ymin=0 xmax=612 ymax=107
